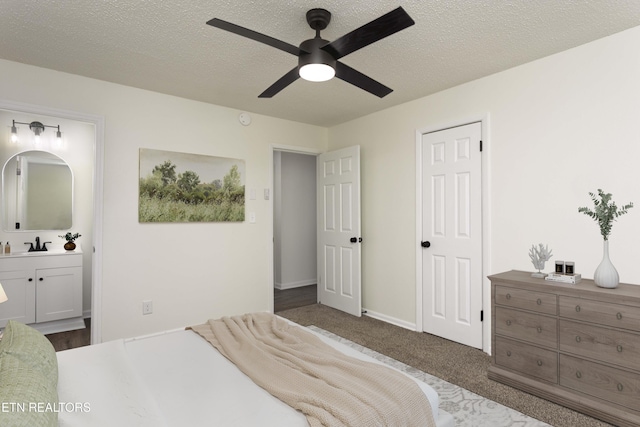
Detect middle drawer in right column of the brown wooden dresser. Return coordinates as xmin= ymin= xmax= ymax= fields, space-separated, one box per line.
xmin=560 ymin=320 xmax=640 ymax=371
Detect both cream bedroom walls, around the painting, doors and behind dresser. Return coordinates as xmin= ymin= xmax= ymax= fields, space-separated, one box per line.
xmin=5 ymin=23 xmax=640 ymax=340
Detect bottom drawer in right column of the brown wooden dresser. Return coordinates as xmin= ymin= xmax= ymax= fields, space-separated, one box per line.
xmin=560 ymin=354 xmax=640 ymax=410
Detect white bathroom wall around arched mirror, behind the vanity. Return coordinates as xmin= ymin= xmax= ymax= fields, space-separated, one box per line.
xmin=0 ymin=110 xmax=95 ymax=314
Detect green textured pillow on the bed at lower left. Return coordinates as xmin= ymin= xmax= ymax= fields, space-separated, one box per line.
xmin=0 ymin=320 xmax=58 ymax=427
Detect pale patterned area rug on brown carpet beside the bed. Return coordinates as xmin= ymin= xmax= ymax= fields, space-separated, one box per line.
xmin=308 ymin=325 xmax=549 ymax=427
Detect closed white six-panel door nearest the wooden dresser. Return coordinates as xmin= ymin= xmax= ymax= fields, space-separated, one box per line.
xmin=422 ymin=123 xmax=482 ymax=348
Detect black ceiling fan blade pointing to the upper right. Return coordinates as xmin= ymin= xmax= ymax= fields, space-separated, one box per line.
xmin=322 ymin=7 xmax=415 ymax=59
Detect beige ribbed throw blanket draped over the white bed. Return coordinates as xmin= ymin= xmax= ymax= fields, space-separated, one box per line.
xmin=191 ymin=313 xmax=435 ymax=427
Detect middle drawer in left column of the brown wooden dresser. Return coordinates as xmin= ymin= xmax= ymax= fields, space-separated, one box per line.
xmin=495 ymin=307 xmax=558 ymax=348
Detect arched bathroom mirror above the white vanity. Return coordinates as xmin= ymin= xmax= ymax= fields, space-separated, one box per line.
xmin=2 ymin=150 xmax=73 ymax=231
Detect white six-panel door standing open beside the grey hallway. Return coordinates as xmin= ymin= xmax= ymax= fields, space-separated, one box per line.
xmin=316 ymin=146 xmax=362 ymax=317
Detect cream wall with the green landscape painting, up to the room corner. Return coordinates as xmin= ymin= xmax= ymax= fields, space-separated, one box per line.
xmin=0 ymin=61 xmax=327 ymax=341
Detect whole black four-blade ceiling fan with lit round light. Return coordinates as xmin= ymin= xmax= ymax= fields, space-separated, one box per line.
xmin=207 ymin=7 xmax=415 ymax=98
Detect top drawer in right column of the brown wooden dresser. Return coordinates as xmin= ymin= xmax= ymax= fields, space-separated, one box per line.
xmin=559 ymin=296 xmax=640 ymax=330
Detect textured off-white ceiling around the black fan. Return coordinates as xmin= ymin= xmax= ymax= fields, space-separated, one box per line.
xmin=0 ymin=0 xmax=640 ymax=126
